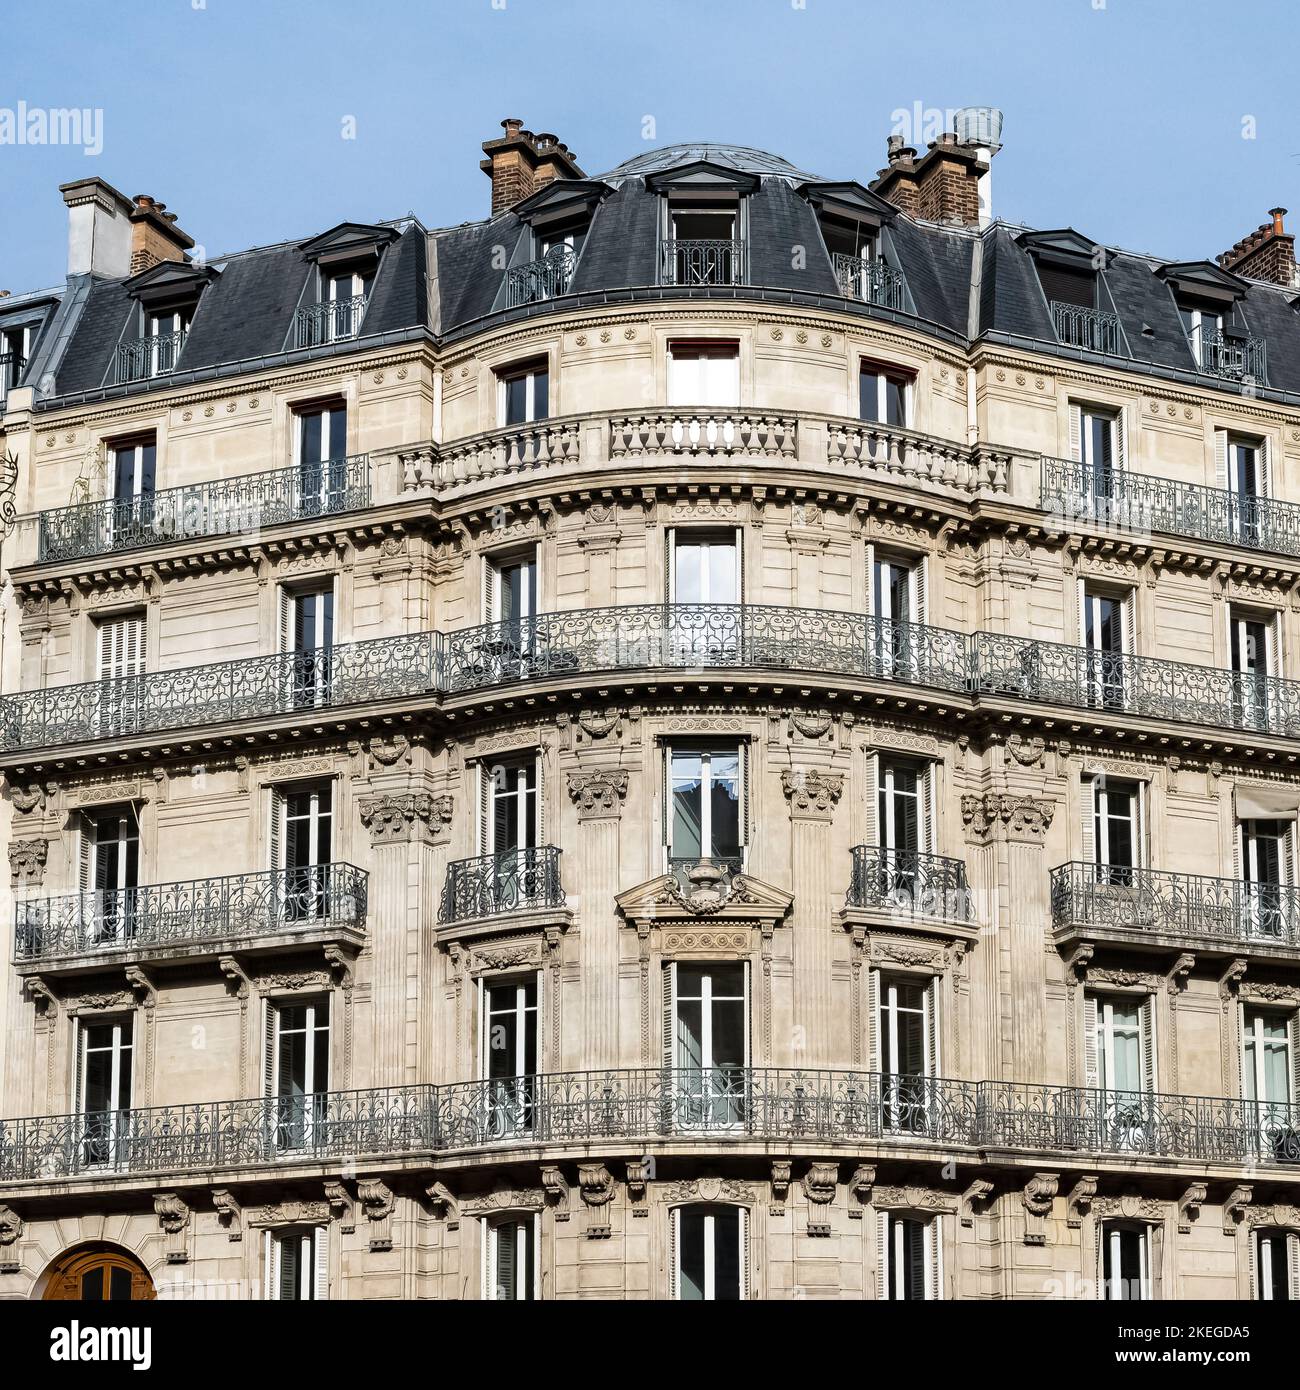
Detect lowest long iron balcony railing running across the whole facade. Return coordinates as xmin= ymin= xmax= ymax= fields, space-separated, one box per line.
xmin=0 ymin=1066 xmax=1300 ymax=1183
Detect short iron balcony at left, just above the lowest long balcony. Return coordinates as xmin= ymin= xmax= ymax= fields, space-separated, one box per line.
xmin=14 ymin=863 xmax=368 ymax=965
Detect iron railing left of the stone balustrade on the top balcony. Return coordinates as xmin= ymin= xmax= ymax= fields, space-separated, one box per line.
xmin=36 ymin=455 xmax=370 ymax=562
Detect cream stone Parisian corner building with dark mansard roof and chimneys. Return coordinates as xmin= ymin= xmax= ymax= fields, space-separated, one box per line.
xmin=0 ymin=121 xmax=1300 ymax=1300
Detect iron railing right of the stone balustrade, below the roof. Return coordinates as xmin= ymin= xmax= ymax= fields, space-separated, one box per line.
xmin=1041 ymin=457 xmax=1300 ymax=556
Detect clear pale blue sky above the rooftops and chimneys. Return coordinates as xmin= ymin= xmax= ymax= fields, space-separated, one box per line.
xmin=0 ymin=0 xmax=1300 ymax=292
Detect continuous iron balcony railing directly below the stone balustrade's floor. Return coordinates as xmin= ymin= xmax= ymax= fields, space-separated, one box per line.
xmin=12 ymin=603 xmax=1300 ymax=753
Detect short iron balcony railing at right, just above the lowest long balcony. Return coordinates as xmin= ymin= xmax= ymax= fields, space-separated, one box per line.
xmin=1051 ymin=860 xmax=1300 ymax=947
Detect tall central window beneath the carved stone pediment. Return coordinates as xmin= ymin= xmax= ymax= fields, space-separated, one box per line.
xmin=663 ymin=960 xmax=749 ymax=1129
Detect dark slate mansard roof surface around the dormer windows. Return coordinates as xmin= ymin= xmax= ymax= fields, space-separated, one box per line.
xmin=10 ymin=145 xmax=1300 ymax=404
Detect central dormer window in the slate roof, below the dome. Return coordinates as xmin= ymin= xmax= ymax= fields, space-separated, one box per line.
xmin=645 ymin=160 xmax=758 ymax=288
